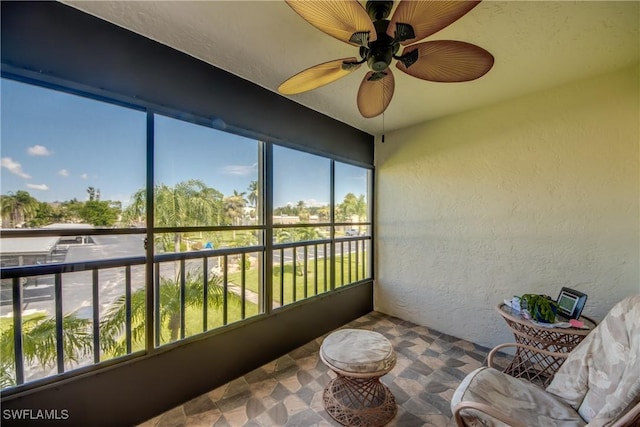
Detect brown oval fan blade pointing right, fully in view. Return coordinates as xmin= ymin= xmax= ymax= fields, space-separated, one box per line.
xmin=396 ymin=40 xmax=494 ymax=83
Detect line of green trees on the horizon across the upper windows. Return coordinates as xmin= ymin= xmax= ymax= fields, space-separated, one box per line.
xmin=0 ymin=179 xmax=367 ymax=232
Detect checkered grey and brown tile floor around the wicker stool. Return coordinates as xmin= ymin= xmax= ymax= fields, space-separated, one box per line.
xmin=139 ymin=312 xmax=508 ymax=427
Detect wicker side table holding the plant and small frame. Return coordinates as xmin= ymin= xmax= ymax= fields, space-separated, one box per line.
xmin=496 ymin=303 xmax=596 ymax=387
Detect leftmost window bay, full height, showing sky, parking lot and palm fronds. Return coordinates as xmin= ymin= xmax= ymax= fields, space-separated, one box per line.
xmin=0 ymin=79 xmax=146 ymax=388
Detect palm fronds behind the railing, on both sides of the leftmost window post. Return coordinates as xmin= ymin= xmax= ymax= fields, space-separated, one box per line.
xmin=100 ymin=271 xmax=228 ymax=356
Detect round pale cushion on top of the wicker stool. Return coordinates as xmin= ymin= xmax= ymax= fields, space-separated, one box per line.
xmin=320 ymin=329 xmax=396 ymax=374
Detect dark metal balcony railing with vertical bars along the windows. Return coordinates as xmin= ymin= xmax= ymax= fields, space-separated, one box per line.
xmin=0 ymin=236 xmax=371 ymax=389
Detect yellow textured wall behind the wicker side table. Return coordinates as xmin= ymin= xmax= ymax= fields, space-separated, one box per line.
xmin=375 ymin=66 xmax=640 ymax=345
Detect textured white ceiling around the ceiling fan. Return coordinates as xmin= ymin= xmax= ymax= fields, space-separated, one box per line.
xmin=65 ymin=0 xmax=640 ymax=134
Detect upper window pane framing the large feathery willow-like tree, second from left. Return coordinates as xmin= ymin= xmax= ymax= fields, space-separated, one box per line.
xmin=154 ymin=116 xmax=260 ymax=227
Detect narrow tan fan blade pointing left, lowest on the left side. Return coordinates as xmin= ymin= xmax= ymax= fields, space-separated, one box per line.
xmin=278 ymin=58 xmax=361 ymax=95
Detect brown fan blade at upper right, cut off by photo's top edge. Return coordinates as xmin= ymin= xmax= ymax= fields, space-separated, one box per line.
xmin=387 ymin=0 xmax=480 ymax=46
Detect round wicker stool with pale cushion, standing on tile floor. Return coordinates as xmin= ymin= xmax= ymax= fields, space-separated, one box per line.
xmin=320 ymin=329 xmax=397 ymax=426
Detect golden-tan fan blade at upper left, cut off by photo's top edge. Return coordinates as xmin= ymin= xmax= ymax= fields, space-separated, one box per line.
xmin=286 ymin=0 xmax=376 ymax=46
